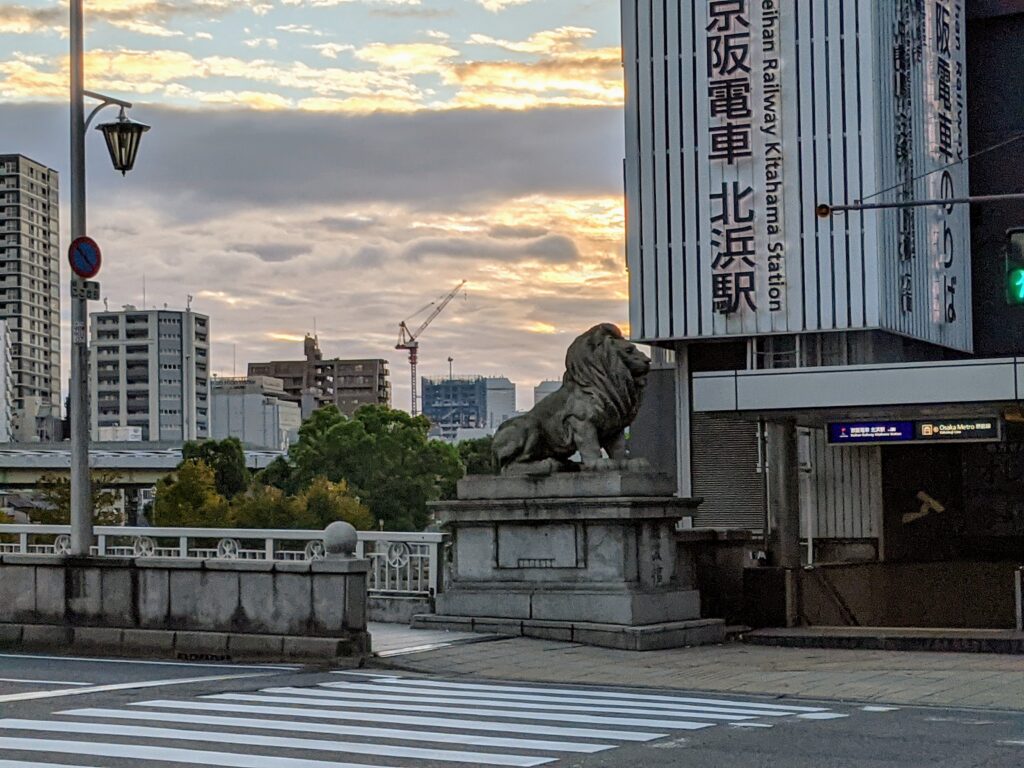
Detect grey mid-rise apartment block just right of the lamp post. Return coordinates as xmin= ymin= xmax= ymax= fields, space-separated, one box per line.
xmin=89 ymin=305 xmax=210 ymax=441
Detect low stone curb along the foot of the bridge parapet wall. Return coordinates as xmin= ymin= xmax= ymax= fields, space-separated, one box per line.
xmin=0 ymin=624 xmax=370 ymax=667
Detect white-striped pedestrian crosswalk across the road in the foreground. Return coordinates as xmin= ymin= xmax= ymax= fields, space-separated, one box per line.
xmin=0 ymin=673 xmax=846 ymax=768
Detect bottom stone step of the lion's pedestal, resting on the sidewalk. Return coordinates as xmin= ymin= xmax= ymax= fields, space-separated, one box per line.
xmin=413 ymin=614 xmax=725 ymax=650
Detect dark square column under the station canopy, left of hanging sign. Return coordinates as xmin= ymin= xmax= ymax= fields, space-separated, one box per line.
xmin=765 ymin=419 xmax=801 ymax=627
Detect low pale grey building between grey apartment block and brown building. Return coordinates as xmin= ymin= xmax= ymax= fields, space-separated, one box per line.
xmin=210 ymin=376 xmax=302 ymax=451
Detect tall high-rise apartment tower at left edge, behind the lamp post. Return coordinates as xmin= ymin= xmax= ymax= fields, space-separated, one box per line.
xmin=0 ymin=155 xmax=60 ymax=418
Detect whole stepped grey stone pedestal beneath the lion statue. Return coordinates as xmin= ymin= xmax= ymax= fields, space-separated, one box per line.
xmin=415 ymin=471 xmax=724 ymax=649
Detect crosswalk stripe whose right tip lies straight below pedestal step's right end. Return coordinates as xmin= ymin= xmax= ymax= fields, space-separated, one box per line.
xmin=207 ymin=693 xmax=712 ymax=731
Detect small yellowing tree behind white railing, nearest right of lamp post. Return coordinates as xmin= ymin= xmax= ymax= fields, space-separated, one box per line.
xmin=153 ymin=459 xmax=229 ymax=528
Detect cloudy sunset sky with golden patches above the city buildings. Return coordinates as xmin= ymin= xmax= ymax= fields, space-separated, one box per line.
xmin=0 ymin=0 xmax=628 ymax=409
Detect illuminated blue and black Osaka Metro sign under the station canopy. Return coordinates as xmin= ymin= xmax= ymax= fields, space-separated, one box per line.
xmin=827 ymin=416 xmax=1001 ymax=445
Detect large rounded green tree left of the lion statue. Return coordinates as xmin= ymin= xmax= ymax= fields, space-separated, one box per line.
xmin=272 ymin=406 xmax=463 ymax=530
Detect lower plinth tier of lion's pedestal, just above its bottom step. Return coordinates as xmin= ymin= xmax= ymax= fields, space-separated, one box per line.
xmin=437 ymin=585 xmax=700 ymax=626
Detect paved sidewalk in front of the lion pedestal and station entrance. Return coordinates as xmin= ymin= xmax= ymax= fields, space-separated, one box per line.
xmin=374 ymin=638 xmax=1024 ymax=712
